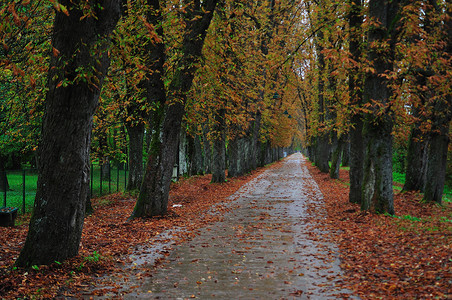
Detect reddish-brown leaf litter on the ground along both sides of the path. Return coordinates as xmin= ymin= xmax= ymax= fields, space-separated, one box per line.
xmin=0 ymin=157 xmax=452 ymax=299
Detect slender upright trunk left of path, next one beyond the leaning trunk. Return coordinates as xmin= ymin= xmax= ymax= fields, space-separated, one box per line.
xmin=212 ymin=108 xmax=226 ymax=183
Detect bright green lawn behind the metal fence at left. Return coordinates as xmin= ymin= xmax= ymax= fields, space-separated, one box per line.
xmin=0 ymin=165 xmax=128 ymax=214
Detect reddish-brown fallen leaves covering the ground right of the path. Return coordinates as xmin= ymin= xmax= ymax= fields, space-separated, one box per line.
xmin=306 ymin=162 xmax=452 ymax=299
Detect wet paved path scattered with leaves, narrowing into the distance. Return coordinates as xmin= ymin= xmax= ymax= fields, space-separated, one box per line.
xmin=94 ymin=153 xmax=357 ymax=299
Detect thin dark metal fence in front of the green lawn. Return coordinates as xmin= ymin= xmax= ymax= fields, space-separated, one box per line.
xmin=0 ymin=164 xmax=128 ymax=214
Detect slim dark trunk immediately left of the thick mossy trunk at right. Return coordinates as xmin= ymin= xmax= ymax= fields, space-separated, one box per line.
xmin=348 ymin=0 xmax=364 ymax=204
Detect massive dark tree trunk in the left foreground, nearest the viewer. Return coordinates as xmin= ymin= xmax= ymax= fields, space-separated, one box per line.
xmin=16 ymin=0 xmax=120 ymax=267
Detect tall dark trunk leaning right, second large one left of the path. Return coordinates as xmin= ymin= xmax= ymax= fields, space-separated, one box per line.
xmin=131 ymin=0 xmax=218 ymax=218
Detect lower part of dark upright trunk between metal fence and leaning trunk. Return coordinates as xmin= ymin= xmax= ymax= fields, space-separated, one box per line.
xmin=126 ymin=123 xmax=144 ymax=191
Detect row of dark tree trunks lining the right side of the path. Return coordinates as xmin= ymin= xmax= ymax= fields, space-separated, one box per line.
xmin=308 ymin=0 xmax=452 ymax=214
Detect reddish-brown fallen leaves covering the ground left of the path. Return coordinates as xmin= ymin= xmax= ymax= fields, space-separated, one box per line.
xmin=0 ymin=163 xmax=279 ymax=299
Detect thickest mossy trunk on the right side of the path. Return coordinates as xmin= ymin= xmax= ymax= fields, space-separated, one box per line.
xmin=361 ymin=0 xmax=399 ymax=214
